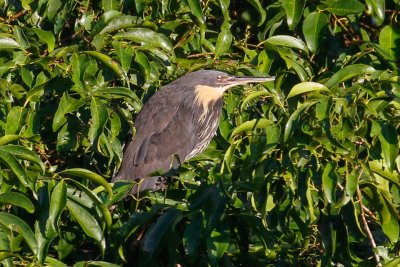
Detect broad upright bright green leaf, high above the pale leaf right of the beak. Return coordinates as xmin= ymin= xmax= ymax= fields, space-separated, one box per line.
xmin=303 ymin=12 xmax=329 ymax=53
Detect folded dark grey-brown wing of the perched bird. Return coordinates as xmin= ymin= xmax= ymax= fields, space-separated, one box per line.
xmin=114 ymin=88 xmax=197 ymax=180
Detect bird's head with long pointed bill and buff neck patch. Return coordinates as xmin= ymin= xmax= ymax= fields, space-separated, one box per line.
xmin=176 ymin=70 xmax=275 ymax=112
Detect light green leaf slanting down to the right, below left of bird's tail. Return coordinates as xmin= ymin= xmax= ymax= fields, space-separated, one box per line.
xmin=67 ymin=198 xmax=105 ymax=251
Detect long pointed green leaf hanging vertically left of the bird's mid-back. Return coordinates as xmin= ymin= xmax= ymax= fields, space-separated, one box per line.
xmin=88 ymin=97 xmax=109 ymax=145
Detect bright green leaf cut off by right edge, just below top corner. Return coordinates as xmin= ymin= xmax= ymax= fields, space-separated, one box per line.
xmin=379 ymin=25 xmax=400 ymax=60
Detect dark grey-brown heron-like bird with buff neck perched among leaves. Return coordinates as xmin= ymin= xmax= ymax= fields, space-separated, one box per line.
xmin=112 ymin=70 xmax=274 ymax=194
